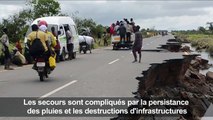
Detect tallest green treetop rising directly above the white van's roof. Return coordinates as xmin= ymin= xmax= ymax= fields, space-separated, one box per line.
xmin=29 ymin=0 xmax=61 ymax=19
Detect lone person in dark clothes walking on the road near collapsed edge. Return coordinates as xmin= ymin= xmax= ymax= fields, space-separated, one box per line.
xmin=132 ymin=26 xmax=143 ymax=63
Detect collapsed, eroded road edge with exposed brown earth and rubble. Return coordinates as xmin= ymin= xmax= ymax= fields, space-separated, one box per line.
xmin=113 ymin=35 xmax=213 ymax=120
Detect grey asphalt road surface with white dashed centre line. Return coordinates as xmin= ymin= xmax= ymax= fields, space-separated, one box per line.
xmin=0 ymin=35 xmax=186 ymax=120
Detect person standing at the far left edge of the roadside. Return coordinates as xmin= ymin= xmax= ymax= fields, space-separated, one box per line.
xmin=0 ymin=28 xmax=13 ymax=70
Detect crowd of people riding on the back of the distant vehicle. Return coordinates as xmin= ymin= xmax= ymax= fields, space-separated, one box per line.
xmin=109 ymin=18 xmax=137 ymax=42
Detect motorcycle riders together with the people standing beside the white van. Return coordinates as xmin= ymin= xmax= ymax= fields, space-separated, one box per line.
xmin=27 ymin=21 xmax=74 ymax=70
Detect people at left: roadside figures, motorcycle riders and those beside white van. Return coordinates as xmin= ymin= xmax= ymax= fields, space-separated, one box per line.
xmin=0 ymin=20 xmax=73 ymax=70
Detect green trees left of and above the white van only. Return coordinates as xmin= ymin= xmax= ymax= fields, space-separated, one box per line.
xmin=0 ymin=0 xmax=61 ymax=43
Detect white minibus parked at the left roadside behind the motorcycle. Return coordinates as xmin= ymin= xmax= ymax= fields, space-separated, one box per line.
xmin=25 ymin=16 xmax=79 ymax=61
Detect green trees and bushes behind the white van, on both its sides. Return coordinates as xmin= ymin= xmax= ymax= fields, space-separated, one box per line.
xmin=0 ymin=0 xmax=107 ymax=50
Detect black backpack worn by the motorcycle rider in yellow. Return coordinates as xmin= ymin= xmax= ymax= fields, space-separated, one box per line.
xmin=29 ymin=33 xmax=45 ymax=57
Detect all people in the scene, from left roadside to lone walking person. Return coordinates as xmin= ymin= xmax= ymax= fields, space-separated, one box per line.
xmin=0 ymin=18 xmax=143 ymax=70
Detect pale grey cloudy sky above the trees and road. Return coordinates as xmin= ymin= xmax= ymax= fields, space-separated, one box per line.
xmin=0 ymin=0 xmax=213 ymax=30
